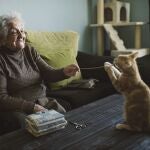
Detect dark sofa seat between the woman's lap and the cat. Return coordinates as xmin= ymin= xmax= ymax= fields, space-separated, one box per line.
xmin=47 ymin=82 xmax=116 ymax=109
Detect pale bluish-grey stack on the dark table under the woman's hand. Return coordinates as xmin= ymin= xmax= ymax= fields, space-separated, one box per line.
xmin=26 ymin=110 xmax=67 ymax=137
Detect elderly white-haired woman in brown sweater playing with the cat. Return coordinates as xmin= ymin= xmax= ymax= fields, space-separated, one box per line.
xmin=0 ymin=14 xmax=79 ymax=126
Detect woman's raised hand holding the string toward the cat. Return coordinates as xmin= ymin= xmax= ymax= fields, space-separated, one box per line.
xmin=63 ymin=64 xmax=79 ymax=77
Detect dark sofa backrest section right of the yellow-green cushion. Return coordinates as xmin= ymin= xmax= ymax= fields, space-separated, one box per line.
xmin=77 ymin=51 xmax=114 ymax=81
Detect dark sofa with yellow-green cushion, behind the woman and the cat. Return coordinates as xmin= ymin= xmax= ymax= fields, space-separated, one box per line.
xmin=0 ymin=31 xmax=150 ymax=134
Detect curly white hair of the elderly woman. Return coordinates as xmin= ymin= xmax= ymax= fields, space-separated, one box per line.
xmin=0 ymin=12 xmax=24 ymax=38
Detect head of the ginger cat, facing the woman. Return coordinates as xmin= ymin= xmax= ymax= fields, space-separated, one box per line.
xmin=114 ymin=52 xmax=138 ymax=71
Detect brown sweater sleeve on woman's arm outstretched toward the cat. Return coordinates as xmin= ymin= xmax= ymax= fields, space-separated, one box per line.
xmin=32 ymin=48 xmax=69 ymax=82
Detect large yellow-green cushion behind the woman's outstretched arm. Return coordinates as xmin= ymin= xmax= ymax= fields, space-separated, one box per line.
xmin=27 ymin=31 xmax=81 ymax=89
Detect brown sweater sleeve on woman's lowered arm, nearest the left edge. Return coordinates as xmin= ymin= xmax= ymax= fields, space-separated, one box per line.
xmin=0 ymin=65 xmax=35 ymax=113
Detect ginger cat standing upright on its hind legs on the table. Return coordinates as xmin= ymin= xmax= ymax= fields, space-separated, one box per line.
xmin=104 ymin=52 xmax=150 ymax=131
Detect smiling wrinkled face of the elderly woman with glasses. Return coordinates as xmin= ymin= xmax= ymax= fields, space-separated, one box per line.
xmin=5 ymin=20 xmax=26 ymax=51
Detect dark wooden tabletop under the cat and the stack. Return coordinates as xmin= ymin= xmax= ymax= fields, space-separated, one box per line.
xmin=0 ymin=95 xmax=150 ymax=150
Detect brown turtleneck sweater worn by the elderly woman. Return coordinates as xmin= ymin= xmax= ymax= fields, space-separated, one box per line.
xmin=0 ymin=45 xmax=67 ymax=113
